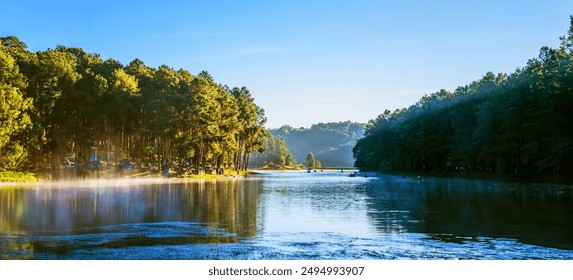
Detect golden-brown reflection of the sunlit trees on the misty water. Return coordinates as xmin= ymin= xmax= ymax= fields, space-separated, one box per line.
xmin=0 ymin=180 xmax=260 ymax=259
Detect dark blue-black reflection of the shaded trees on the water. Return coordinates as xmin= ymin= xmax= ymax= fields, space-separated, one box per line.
xmin=365 ymin=176 xmax=573 ymax=250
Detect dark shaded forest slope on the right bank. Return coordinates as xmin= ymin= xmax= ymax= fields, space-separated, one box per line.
xmin=353 ymin=17 xmax=573 ymax=180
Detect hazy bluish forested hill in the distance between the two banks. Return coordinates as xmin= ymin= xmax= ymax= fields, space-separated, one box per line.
xmin=269 ymin=121 xmax=364 ymax=167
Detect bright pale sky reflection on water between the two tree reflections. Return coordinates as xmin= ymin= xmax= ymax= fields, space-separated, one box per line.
xmin=260 ymin=172 xmax=377 ymax=237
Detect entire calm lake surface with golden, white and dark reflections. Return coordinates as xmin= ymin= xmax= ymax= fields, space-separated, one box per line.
xmin=0 ymin=171 xmax=573 ymax=259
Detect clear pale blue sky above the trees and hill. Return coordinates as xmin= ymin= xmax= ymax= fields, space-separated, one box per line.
xmin=0 ymin=0 xmax=573 ymax=128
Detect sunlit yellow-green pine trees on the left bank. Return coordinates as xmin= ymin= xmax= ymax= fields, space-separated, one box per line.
xmin=0 ymin=36 xmax=268 ymax=174
